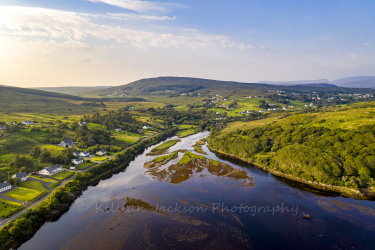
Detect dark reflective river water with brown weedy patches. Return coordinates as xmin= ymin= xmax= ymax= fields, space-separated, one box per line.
xmin=20 ymin=132 xmax=375 ymax=250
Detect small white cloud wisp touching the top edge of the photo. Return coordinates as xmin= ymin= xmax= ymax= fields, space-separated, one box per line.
xmin=87 ymin=0 xmax=181 ymax=13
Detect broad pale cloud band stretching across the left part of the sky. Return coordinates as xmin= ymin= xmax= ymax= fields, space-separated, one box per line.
xmin=0 ymin=6 xmax=253 ymax=49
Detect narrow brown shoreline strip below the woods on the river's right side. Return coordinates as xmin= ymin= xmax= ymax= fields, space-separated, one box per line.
xmin=207 ymin=145 xmax=375 ymax=200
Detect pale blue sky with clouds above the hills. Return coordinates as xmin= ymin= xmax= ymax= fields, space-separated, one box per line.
xmin=0 ymin=0 xmax=375 ymax=87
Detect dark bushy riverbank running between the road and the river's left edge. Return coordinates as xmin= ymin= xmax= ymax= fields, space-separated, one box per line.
xmin=0 ymin=130 xmax=176 ymax=249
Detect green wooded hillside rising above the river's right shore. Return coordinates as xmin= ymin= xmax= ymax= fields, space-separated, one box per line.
xmin=209 ymin=103 xmax=375 ymax=188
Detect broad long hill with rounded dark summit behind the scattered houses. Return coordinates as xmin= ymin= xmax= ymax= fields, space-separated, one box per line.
xmin=88 ymin=77 xmax=374 ymax=97
